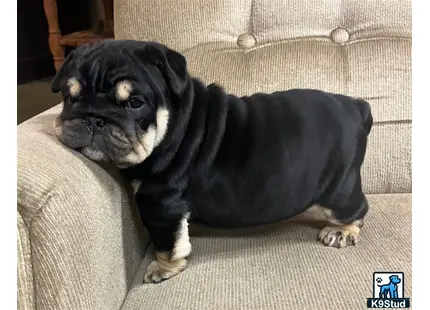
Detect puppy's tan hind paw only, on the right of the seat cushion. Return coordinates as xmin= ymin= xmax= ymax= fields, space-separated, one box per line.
xmin=318 ymin=225 xmax=360 ymax=248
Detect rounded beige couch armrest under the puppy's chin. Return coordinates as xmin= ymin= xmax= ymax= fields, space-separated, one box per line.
xmin=17 ymin=106 xmax=148 ymax=310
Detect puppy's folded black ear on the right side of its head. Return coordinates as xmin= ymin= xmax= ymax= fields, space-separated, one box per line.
xmin=137 ymin=44 xmax=188 ymax=96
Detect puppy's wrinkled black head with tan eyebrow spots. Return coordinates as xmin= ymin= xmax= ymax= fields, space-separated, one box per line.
xmin=52 ymin=40 xmax=189 ymax=168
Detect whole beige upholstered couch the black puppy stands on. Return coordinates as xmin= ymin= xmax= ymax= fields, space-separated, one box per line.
xmin=17 ymin=0 xmax=412 ymax=310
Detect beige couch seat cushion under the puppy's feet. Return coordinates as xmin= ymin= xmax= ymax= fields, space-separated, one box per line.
xmin=122 ymin=194 xmax=412 ymax=310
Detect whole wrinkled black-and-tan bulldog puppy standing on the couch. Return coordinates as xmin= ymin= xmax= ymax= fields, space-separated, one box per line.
xmin=52 ymin=40 xmax=372 ymax=282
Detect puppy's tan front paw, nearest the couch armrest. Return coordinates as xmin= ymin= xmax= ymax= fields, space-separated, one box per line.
xmin=144 ymin=253 xmax=187 ymax=283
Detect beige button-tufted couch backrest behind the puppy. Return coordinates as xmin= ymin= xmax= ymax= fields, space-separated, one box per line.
xmin=114 ymin=0 xmax=412 ymax=193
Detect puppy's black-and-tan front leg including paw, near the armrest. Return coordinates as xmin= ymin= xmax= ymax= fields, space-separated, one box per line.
xmin=140 ymin=206 xmax=191 ymax=283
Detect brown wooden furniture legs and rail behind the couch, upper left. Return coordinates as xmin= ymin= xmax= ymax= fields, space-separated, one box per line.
xmin=43 ymin=0 xmax=113 ymax=71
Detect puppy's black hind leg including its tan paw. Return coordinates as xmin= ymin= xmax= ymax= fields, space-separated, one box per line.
xmin=318 ymin=169 xmax=369 ymax=248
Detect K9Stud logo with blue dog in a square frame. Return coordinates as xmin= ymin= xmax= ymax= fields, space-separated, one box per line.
xmin=367 ymin=272 xmax=410 ymax=308
